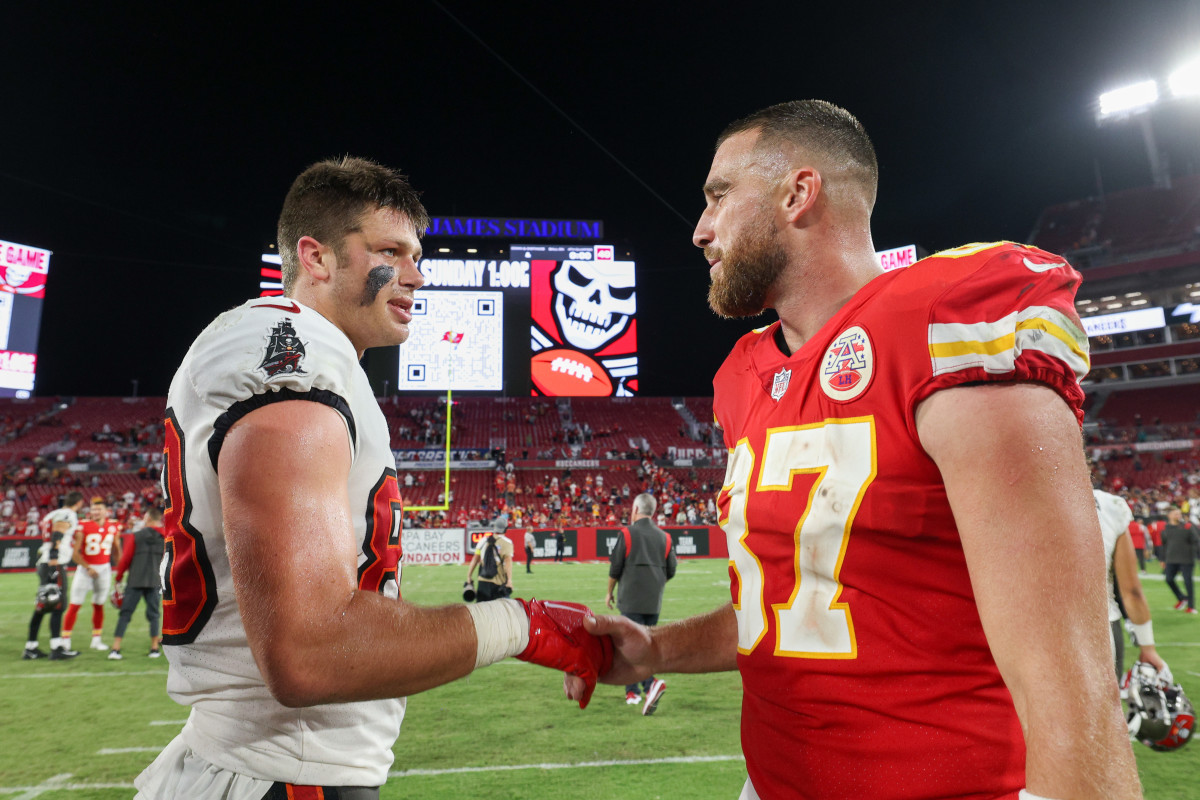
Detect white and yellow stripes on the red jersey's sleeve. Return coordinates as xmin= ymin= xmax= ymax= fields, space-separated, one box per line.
xmin=929 ymin=306 xmax=1090 ymax=380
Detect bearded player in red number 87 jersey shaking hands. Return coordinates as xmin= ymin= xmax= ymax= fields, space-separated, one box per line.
xmin=576 ymin=101 xmax=1140 ymax=800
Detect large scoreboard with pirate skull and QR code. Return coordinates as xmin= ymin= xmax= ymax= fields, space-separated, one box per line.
xmin=259 ymin=242 xmax=638 ymax=397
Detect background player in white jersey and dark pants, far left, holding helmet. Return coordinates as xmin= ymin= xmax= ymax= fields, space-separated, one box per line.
xmin=22 ymin=492 xmax=83 ymax=661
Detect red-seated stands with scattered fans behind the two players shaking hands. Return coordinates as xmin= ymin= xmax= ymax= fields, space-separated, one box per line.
xmin=0 ymin=397 xmax=724 ymax=533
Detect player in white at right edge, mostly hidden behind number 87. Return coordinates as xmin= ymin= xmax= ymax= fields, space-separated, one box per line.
xmin=1092 ymin=489 xmax=1171 ymax=684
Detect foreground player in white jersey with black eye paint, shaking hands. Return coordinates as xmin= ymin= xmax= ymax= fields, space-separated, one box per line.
xmin=136 ymin=157 xmax=612 ymax=800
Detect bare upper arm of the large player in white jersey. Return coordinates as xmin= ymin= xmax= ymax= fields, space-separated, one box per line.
xmin=218 ymin=401 xmax=356 ymax=657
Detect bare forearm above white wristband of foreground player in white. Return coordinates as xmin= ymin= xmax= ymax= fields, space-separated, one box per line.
xmin=255 ymin=590 xmax=476 ymax=706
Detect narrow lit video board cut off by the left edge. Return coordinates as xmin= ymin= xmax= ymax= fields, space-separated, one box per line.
xmin=0 ymin=240 xmax=50 ymax=397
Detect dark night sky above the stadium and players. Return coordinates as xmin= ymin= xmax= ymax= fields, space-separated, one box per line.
xmin=0 ymin=0 xmax=1200 ymax=395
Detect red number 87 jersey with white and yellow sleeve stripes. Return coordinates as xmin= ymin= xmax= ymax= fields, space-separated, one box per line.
xmin=714 ymin=242 xmax=1088 ymax=800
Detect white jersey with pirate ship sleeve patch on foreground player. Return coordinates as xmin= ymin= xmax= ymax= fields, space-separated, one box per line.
xmin=151 ymin=297 xmax=404 ymax=786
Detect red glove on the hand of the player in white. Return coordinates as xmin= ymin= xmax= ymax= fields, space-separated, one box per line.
xmin=517 ymin=600 xmax=612 ymax=709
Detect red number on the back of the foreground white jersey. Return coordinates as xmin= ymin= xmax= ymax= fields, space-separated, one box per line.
xmin=160 ymin=409 xmax=217 ymax=644
